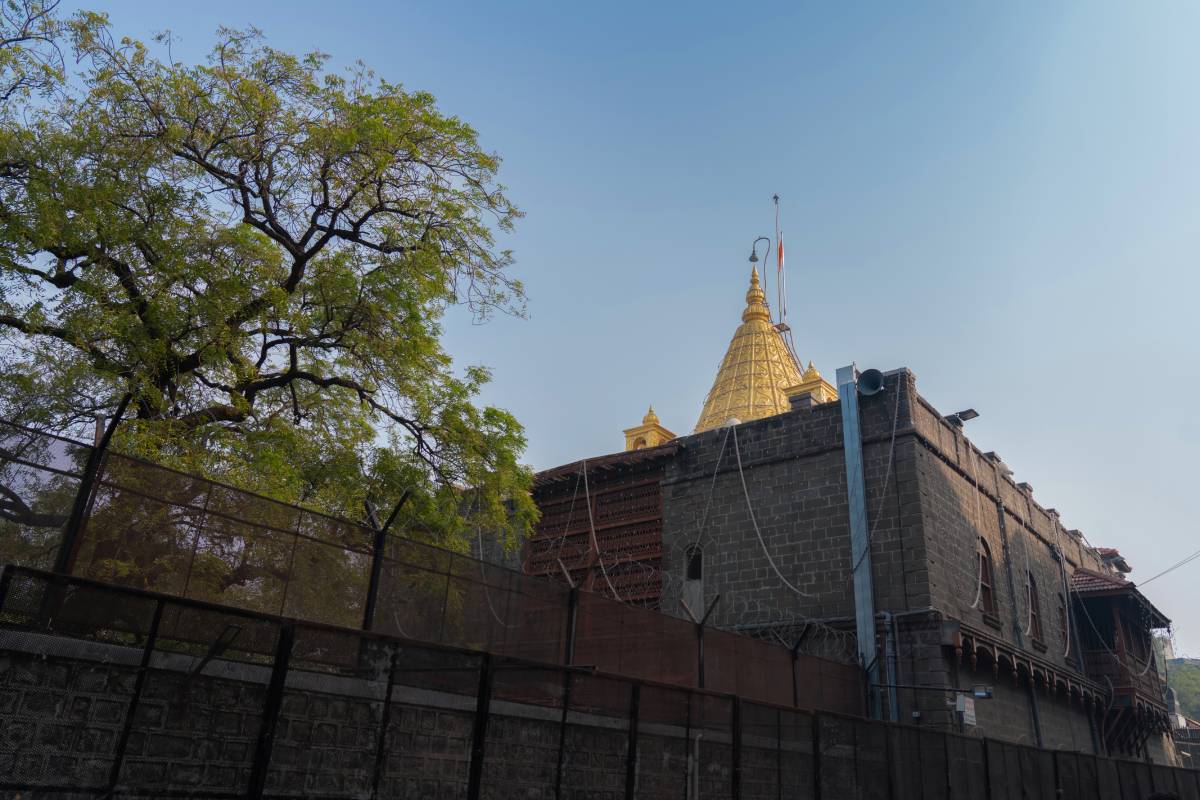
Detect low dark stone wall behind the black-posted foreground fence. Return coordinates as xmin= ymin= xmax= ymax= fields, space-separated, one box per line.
xmin=0 ymin=633 xmax=748 ymax=800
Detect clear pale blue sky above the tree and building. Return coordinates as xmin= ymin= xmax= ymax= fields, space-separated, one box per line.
xmin=63 ymin=0 xmax=1200 ymax=655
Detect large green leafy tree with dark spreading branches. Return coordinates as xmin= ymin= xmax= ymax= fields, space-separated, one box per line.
xmin=0 ymin=10 xmax=535 ymax=563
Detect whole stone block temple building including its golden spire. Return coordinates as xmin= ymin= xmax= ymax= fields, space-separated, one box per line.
xmin=526 ymin=263 xmax=1177 ymax=763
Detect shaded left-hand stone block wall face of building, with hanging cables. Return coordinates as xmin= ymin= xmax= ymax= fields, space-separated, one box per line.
xmin=664 ymin=371 xmax=930 ymax=628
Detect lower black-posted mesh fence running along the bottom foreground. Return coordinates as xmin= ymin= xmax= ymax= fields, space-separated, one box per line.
xmin=0 ymin=567 xmax=1200 ymax=800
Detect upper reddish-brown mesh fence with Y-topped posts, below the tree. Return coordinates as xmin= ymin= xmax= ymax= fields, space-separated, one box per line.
xmin=0 ymin=422 xmax=863 ymax=712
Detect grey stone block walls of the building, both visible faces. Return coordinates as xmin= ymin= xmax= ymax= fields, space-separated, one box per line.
xmin=648 ymin=369 xmax=1165 ymax=758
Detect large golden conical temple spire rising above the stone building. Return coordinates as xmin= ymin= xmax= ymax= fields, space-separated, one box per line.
xmin=694 ymin=267 xmax=811 ymax=433
